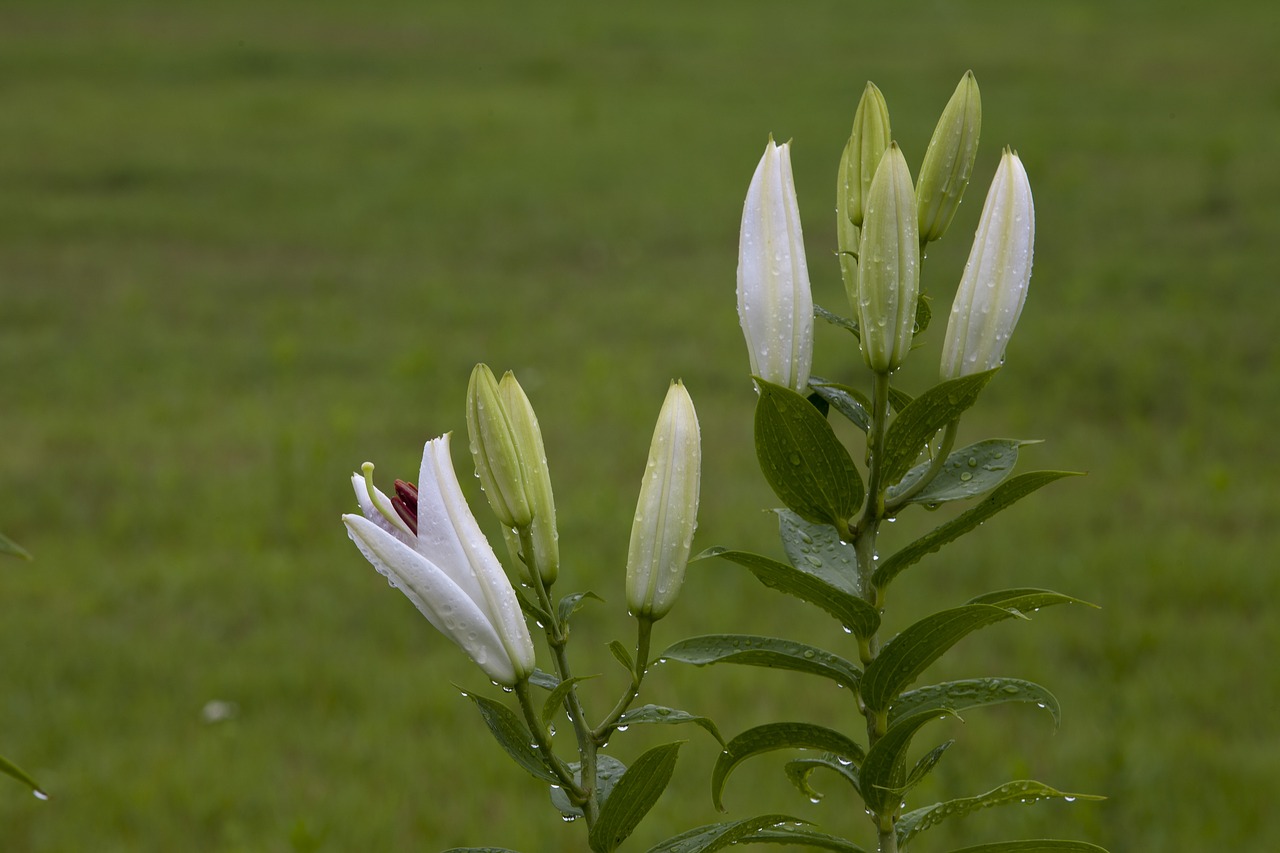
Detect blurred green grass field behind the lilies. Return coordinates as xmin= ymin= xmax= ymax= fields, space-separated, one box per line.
xmin=0 ymin=0 xmax=1280 ymax=853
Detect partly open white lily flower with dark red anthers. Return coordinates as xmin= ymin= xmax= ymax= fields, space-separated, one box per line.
xmin=342 ymin=434 xmax=534 ymax=686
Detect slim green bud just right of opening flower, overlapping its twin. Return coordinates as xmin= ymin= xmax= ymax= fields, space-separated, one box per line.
xmin=467 ymin=364 xmax=534 ymax=528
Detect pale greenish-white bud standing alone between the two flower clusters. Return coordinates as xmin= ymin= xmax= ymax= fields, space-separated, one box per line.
xmin=627 ymin=382 xmax=703 ymax=621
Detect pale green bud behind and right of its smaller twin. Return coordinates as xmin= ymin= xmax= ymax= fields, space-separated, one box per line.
xmin=498 ymin=370 xmax=559 ymax=587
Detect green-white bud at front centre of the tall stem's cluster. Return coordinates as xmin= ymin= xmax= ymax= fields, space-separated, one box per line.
xmin=854 ymin=142 xmax=920 ymax=373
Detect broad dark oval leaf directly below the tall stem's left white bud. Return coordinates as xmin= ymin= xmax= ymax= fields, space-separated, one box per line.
xmin=755 ymin=378 xmax=863 ymax=524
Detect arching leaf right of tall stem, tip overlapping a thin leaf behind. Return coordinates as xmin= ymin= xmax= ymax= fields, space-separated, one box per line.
xmin=861 ymin=605 xmax=1014 ymax=712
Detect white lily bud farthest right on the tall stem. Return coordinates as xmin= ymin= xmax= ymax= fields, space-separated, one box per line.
xmin=941 ymin=149 xmax=1036 ymax=379
